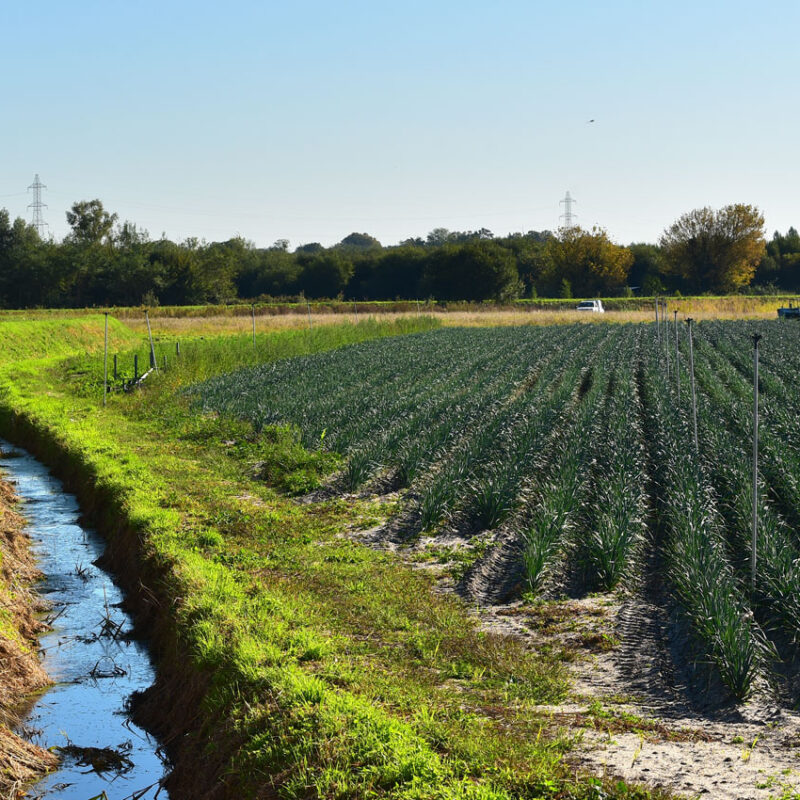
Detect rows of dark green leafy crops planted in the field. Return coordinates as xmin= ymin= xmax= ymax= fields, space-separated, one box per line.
xmin=192 ymin=322 xmax=800 ymax=699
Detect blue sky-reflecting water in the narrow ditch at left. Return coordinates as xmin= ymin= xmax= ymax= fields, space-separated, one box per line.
xmin=0 ymin=441 xmax=168 ymax=800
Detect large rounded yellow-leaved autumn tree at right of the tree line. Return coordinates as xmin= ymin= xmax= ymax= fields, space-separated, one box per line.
xmin=660 ymin=203 xmax=765 ymax=293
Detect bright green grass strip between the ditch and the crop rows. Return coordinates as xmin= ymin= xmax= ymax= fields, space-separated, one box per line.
xmin=0 ymin=323 xmax=668 ymax=800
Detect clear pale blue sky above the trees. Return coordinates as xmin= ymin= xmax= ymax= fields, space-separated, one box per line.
xmin=0 ymin=0 xmax=800 ymax=249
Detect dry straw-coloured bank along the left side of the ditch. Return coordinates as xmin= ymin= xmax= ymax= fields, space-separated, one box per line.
xmin=0 ymin=481 xmax=58 ymax=798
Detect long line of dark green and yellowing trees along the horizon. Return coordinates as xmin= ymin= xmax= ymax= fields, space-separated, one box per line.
xmin=0 ymin=200 xmax=800 ymax=308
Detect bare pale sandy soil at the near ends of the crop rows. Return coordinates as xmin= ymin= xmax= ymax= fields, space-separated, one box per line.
xmin=350 ymin=506 xmax=800 ymax=800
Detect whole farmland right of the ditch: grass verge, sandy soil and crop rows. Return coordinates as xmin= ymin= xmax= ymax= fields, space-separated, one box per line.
xmin=0 ymin=315 xmax=800 ymax=800
